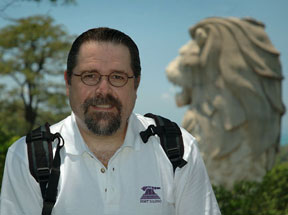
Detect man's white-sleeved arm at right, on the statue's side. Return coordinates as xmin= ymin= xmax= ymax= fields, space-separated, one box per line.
xmin=175 ymin=137 xmax=221 ymax=215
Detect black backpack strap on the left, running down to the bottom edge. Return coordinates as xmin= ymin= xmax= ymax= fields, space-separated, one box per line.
xmin=26 ymin=123 xmax=64 ymax=215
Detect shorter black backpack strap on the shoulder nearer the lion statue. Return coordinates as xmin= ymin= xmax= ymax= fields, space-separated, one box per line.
xmin=140 ymin=113 xmax=187 ymax=172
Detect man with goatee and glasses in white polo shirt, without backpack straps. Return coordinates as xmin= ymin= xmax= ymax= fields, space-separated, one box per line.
xmin=0 ymin=28 xmax=220 ymax=215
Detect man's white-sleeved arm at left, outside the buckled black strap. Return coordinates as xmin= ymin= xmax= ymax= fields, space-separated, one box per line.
xmin=0 ymin=138 xmax=42 ymax=215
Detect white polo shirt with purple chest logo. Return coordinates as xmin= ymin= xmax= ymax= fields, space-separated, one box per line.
xmin=0 ymin=113 xmax=220 ymax=215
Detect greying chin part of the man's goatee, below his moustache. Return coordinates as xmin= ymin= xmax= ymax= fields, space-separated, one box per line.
xmin=84 ymin=112 xmax=121 ymax=136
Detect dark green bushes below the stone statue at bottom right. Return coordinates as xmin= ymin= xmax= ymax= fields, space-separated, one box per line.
xmin=213 ymin=162 xmax=288 ymax=215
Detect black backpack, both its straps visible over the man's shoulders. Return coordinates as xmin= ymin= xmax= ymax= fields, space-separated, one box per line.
xmin=26 ymin=113 xmax=187 ymax=215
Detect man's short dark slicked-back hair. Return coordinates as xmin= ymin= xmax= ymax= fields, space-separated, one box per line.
xmin=67 ymin=27 xmax=141 ymax=84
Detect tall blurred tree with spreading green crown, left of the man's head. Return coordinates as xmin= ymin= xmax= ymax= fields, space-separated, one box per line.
xmin=0 ymin=16 xmax=72 ymax=131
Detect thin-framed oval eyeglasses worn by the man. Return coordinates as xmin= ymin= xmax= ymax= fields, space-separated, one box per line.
xmin=73 ymin=71 xmax=135 ymax=87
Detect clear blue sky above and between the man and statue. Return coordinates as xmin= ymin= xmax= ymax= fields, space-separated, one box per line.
xmin=0 ymin=0 xmax=288 ymax=144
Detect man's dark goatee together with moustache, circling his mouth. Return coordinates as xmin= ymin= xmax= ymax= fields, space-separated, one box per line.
xmin=82 ymin=94 xmax=122 ymax=136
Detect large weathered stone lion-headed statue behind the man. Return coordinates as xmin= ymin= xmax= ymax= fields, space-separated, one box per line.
xmin=166 ymin=17 xmax=285 ymax=188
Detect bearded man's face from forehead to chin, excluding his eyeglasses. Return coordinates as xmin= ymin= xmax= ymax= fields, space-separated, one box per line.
xmin=65 ymin=41 xmax=141 ymax=136
